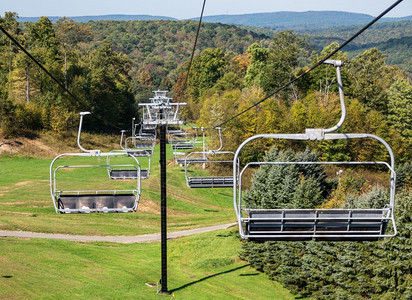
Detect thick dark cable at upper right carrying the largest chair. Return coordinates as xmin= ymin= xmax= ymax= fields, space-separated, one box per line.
xmin=215 ymin=0 xmax=403 ymax=128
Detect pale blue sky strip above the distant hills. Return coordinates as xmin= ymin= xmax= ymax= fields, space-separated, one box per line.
xmin=0 ymin=0 xmax=412 ymax=19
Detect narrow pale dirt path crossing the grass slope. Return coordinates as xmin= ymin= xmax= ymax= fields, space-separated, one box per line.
xmin=0 ymin=223 xmax=237 ymax=244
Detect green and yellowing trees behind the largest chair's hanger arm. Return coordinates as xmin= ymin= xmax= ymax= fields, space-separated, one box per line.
xmin=182 ymin=31 xmax=412 ymax=162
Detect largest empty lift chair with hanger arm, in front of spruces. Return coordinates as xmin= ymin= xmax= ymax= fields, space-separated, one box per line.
xmin=233 ymin=60 xmax=397 ymax=241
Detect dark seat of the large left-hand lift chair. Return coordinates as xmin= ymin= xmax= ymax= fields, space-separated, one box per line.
xmin=56 ymin=193 xmax=137 ymax=213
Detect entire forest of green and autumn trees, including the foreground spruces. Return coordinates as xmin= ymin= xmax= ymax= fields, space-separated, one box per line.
xmin=0 ymin=12 xmax=412 ymax=299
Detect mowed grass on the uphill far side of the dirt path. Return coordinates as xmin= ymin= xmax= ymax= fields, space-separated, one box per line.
xmin=0 ymin=145 xmax=235 ymax=235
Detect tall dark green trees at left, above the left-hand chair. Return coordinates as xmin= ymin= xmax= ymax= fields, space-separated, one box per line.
xmin=0 ymin=12 xmax=137 ymax=136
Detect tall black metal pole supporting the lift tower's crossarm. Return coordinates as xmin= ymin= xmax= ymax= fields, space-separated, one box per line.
xmin=160 ymin=120 xmax=169 ymax=294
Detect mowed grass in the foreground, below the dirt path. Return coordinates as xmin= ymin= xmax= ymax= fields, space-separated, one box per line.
xmin=0 ymin=229 xmax=294 ymax=299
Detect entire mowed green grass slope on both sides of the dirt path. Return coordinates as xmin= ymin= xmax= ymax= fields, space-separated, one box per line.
xmin=0 ymin=135 xmax=294 ymax=299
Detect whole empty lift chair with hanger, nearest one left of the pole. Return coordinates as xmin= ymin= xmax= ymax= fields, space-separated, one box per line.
xmin=50 ymin=112 xmax=140 ymax=213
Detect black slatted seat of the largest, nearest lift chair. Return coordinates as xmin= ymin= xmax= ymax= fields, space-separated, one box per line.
xmin=244 ymin=208 xmax=390 ymax=241
